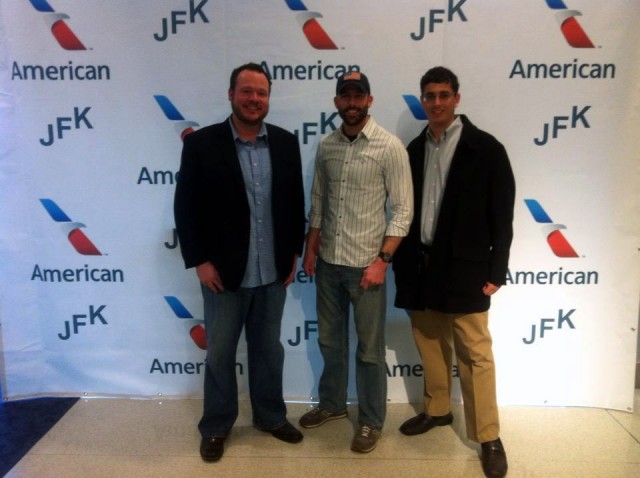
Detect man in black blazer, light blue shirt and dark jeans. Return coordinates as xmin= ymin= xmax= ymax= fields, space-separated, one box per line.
xmin=174 ymin=63 xmax=305 ymax=461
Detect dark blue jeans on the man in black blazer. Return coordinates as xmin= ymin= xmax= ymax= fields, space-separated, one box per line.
xmin=198 ymin=282 xmax=287 ymax=437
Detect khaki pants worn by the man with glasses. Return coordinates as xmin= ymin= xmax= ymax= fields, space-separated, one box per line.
xmin=411 ymin=310 xmax=500 ymax=443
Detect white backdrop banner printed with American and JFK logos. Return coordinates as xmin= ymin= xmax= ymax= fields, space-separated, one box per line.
xmin=0 ymin=0 xmax=640 ymax=410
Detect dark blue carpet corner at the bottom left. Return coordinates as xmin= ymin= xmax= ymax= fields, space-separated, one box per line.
xmin=0 ymin=398 xmax=78 ymax=476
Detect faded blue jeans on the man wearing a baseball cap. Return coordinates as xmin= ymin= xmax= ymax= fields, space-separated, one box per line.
xmin=316 ymin=259 xmax=387 ymax=428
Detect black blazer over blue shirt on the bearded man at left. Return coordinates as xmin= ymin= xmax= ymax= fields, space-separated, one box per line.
xmin=174 ymin=120 xmax=305 ymax=291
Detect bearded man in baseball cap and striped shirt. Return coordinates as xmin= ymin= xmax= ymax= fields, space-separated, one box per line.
xmin=300 ymin=71 xmax=413 ymax=453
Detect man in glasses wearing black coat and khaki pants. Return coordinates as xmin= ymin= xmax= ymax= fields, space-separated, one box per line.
xmin=394 ymin=67 xmax=515 ymax=477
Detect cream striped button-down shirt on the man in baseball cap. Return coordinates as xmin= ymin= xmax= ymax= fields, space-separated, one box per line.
xmin=309 ymin=117 xmax=413 ymax=267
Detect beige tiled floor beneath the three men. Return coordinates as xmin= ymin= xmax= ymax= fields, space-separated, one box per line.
xmin=6 ymin=391 xmax=640 ymax=478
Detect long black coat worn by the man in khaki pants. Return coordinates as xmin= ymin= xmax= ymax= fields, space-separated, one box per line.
xmin=393 ymin=115 xmax=515 ymax=313
